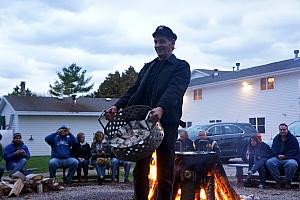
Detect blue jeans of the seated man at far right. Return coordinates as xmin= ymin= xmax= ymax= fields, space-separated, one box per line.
xmin=267 ymin=157 xmax=298 ymax=182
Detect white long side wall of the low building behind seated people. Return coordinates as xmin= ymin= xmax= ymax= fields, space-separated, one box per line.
xmin=19 ymin=116 xmax=103 ymax=156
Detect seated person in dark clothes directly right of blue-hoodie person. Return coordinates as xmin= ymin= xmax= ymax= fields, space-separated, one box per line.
xmin=71 ymin=133 xmax=91 ymax=182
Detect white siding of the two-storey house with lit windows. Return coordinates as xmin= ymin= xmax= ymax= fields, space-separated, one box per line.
xmin=183 ymin=72 xmax=300 ymax=139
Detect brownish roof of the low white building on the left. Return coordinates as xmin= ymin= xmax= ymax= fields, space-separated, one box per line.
xmin=3 ymin=96 xmax=118 ymax=112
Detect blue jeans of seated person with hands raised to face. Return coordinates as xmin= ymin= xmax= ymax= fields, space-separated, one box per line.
xmin=49 ymin=158 xmax=78 ymax=181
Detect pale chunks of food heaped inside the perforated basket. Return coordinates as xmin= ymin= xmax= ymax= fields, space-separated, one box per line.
xmin=109 ymin=120 xmax=153 ymax=148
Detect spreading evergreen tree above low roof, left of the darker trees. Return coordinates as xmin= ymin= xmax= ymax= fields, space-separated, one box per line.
xmin=49 ymin=63 xmax=94 ymax=96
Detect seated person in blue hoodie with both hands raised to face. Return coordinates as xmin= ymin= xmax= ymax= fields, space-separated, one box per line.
xmin=45 ymin=126 xmax=78 ymax=184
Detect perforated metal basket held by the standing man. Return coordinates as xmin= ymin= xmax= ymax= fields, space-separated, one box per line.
xmin=99 ymin=105 xmax=164 ymax=162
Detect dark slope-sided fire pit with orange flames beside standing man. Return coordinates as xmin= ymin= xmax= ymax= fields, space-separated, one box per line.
xmin=173 ymin=152 xmax=240 ymax=200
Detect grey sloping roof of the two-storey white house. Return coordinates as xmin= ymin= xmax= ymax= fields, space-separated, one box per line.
xmin=189 ymin=59 xmax=300 ymax=87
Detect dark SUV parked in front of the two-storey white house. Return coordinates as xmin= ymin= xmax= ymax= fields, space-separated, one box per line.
xmin=186 ymin=123 xmax=258 ymax=162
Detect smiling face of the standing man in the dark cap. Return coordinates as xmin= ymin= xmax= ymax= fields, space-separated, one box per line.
xmin=154 ymin=36 xmax=175 ymax=60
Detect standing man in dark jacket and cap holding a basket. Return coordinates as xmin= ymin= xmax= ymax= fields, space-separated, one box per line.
xmin=106 ymin=26 xmax=191 ymax=200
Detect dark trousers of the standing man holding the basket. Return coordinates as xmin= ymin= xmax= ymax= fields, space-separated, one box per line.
xmin=133 ymin=124 xmax=178 ymax=200
